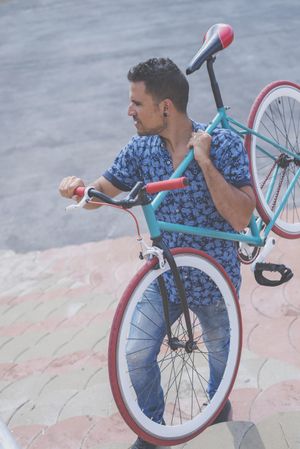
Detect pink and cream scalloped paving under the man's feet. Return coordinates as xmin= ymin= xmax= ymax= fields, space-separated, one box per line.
xmin=0 ymin=233 xmax=300 ymax=449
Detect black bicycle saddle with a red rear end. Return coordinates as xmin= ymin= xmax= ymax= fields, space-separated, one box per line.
xmin=186 ymin=23 xmax=234 ymax=75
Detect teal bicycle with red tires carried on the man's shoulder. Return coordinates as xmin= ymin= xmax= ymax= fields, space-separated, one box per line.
xmin=65 ymin=24 xmax=300 ymax=445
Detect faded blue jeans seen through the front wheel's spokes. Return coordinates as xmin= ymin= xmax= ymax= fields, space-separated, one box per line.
xmin=126 ymin=284 xmax=230 ymax=422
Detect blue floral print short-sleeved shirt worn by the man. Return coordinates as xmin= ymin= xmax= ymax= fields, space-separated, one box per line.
xmin=104 ymin=122 xmax=251 ymax=305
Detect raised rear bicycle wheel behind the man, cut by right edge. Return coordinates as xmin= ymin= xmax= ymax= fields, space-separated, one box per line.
xmin=245 ymin=81 xmax=300 ymax=239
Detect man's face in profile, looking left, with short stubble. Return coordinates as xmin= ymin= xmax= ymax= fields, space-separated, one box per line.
xmin=128 ymin=81 xmax=167 ymax=136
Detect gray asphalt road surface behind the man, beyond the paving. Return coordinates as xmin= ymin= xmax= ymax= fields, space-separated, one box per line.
xmin=0 ymin=0 xmax=300 ymax=252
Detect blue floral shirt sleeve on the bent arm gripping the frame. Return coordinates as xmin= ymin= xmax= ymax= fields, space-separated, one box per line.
xmin=212 ymin=129 xmax=252 ymax=187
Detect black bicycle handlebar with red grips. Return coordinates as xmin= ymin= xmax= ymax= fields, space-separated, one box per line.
xmin=74 ymin=176 xmax=189 ymax=209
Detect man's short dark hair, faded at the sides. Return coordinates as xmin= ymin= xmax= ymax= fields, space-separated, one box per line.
xmin=127 ymin=58 xmax=189 ymax=113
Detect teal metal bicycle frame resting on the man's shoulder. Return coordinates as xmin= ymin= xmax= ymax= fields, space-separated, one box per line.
xmin=143 ymin=107 xmax=300 ymax=247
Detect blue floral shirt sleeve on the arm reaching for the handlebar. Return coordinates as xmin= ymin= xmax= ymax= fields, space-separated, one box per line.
xmin=103 ymin=140 xmax=140 ymax=192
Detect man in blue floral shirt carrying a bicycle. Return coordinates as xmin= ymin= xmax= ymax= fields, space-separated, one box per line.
xmin=59 ymin=58 xmax=255 ymax=449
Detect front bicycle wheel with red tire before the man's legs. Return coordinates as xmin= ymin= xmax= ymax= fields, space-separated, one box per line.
xmin=108 ymin=248 xmax=242 ymax=445
